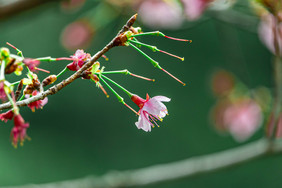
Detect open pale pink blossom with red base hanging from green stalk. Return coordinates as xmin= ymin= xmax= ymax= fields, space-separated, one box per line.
xmin=131 ymin=95 xmax=170 ymax=132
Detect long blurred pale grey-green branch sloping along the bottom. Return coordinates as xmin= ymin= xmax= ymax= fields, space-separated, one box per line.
xmin=2 ymin=139 xmax=282 ymax=188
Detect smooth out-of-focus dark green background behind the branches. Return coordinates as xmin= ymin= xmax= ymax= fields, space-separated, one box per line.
xmin=0 ymin=0 xmax=282 ymax=188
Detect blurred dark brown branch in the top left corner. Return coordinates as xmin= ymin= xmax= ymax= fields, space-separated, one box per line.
xmin=0 ymin=0 xmax=56 ymax=19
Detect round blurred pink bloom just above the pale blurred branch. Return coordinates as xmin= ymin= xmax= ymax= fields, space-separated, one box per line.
xmin=223 ymin=99 xmax=263 ymax=142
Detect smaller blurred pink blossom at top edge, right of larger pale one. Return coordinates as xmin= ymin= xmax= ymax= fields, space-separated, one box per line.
xmin=182 ymin=0 xmax=212 ymax=20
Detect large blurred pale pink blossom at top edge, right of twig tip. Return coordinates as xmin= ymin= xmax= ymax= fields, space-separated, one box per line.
xmin=137 ymin=0 xmax=183 ymax=29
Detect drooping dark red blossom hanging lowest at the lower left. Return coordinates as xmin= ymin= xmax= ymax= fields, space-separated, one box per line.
xmin=11 ymin=114 xmax=29 ymax=147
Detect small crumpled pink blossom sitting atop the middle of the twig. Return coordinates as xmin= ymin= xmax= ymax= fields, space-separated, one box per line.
xmin=67 ymin=50 xmax=91 ymax=71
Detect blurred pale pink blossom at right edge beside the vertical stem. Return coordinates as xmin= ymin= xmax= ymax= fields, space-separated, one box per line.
xmin=259 ymin=14 xmax=282 ymax=55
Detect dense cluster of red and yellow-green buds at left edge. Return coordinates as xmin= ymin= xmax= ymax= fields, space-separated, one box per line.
xmin=0 ymin=43 xmax=65 ymax=147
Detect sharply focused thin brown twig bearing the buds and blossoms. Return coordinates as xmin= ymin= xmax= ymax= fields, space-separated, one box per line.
xmin=0 ymin=14 xmax=137 ymax=110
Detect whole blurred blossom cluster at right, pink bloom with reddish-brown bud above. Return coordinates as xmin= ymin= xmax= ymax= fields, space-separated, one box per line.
xmin=211 ymin=70 xmax=271 ymax=142
